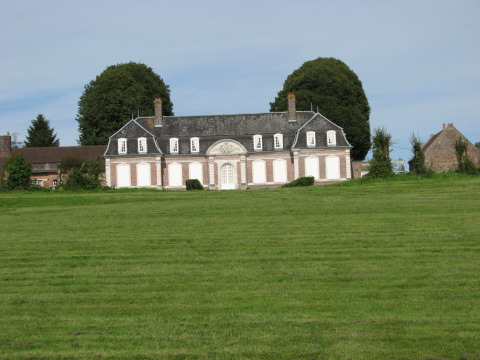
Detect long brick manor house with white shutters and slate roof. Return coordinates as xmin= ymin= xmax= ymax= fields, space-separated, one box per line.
xmin=104 ymin=94 xmax=352 ymax=190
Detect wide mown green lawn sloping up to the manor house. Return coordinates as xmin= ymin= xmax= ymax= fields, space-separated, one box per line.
xmin=0 ymin=175 xmax=480 ymax=360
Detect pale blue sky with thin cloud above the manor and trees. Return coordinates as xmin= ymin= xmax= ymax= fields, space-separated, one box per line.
xmin=0 ymin=0 xmax=480 ymax=160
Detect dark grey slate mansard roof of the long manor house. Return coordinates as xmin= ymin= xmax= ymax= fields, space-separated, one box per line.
xmin=105 ymin=111 xmax=351 ymax=156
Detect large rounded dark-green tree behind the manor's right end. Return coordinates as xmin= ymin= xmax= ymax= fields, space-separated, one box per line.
xmin=270 ymin=58 xmax=371 ymax=160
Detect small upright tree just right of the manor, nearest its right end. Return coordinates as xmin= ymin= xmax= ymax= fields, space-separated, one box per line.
xmin=366 ymin=128 xmax=394 ymax=178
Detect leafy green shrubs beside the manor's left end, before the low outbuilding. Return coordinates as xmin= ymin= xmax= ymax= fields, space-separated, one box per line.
xmin=57 ymin=157 xmax=103 ymax=190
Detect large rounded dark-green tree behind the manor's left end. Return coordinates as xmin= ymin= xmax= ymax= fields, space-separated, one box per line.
xmin=77 ymin=62 xmax=173 ymax=145
